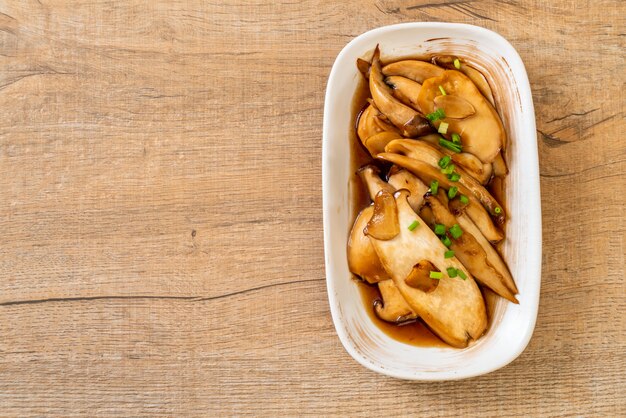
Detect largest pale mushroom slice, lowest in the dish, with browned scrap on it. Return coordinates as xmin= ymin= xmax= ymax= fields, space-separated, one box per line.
xmin=370 ymin=190 xmax=487 ymax=348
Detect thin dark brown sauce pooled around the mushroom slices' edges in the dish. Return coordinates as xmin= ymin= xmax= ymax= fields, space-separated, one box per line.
xmin=349 ymin=56 xmax=506 ymax=347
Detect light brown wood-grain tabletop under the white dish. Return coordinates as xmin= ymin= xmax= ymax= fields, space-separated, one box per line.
xmin=0 ymin=0 xmax=626 ymax=417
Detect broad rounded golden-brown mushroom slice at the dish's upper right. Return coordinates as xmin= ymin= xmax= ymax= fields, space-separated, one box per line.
xmin=418 ymin=70 xmax=505 ymax=163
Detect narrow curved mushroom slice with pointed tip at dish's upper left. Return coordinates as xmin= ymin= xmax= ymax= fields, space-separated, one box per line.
xmin=369 ymin=46 xmax=430 ymax=136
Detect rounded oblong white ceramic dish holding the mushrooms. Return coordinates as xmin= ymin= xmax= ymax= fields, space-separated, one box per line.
xmin=322 ymin=23 xmax=541 ymax=380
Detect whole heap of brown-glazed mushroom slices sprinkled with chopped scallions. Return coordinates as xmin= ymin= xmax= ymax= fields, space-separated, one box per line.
xmin=347 ymin=47 xmax=518 ymax=348
